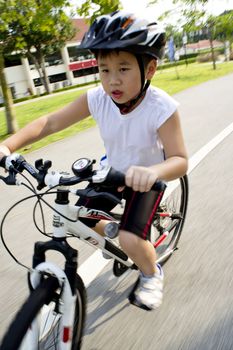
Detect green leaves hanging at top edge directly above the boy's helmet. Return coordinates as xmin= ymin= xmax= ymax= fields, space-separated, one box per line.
xmin=77 ymin=0 xmax=122 ymax=23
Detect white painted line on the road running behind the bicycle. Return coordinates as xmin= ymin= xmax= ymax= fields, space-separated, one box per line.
xmin=78 ymin=123 xmax=233 ymax=287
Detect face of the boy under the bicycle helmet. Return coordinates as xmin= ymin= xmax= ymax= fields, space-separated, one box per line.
xmin=98 ymin=51 xmax=141 ymax=103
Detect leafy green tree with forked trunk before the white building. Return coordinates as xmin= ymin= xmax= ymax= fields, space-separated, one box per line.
xmin=13 ymin=0 xmax=75 ymax=93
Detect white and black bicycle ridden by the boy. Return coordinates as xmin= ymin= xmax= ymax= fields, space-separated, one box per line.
xmin=0 ymin=155 xmax=188 ymax=350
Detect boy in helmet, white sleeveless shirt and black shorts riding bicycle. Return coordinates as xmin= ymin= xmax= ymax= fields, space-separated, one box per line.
xmin=0 ymin=11 xmax=187 ymax=309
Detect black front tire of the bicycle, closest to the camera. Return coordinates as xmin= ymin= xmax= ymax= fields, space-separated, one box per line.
xmin=0 ymin=275 xmax=86 ymax=350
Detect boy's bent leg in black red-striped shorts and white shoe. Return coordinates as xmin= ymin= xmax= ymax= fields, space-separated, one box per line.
xmin=119 ymin=190 xmax=163 ymax=310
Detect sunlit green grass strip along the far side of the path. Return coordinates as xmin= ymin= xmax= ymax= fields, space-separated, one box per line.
xmin=0 ymin=61 xmax=233 ymax=153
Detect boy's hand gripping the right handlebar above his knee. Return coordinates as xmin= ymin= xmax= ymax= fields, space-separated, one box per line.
xmin=125 ymin=166 xmax=158 ymax=192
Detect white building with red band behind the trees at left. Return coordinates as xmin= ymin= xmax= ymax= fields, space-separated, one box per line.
xmin=0 ymin=18 xmax=98 ymax=102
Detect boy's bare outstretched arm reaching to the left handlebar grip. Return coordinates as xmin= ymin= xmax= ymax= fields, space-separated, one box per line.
xmin=0 ymin=94 xmax=90 ymax=159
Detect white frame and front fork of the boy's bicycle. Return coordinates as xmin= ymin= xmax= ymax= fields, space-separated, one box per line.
xmin=20 ymin=187 xmax=133 ymax=350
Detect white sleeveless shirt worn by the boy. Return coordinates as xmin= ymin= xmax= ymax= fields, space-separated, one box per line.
xmin=87 ymin=86 xmax=178 ymax=173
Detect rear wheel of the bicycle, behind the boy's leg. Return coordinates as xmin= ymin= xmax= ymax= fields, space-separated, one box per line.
xmin=150 ymin=175 xmax=189 ymax=264
